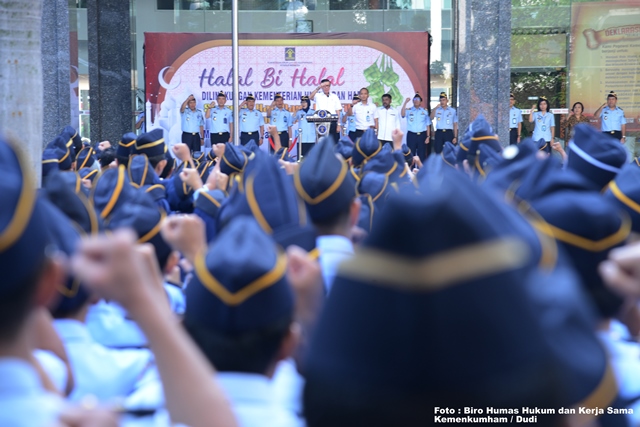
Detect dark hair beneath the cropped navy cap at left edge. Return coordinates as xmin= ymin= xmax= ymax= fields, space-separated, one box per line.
xmin=0 ymin=260 xmax=46 ymax=343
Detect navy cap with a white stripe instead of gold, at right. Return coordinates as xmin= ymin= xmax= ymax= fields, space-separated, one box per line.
xmin=567 ymin=123 xmax=627 ymax=188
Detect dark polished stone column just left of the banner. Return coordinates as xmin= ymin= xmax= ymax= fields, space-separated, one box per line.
xmin=87 ymin=0 xmax=133 ymax=142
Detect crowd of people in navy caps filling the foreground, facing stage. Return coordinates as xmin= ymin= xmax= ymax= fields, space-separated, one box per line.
xmin=0 ymin=83 xmax=640 ymax=427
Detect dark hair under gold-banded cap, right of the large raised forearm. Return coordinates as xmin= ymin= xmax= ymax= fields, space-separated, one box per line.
xmin=184 ymin=317 xmax=292 ymax=375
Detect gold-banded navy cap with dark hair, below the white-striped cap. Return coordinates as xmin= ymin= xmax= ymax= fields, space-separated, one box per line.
xmin=530 ymin=184 xmax=631 ymax=318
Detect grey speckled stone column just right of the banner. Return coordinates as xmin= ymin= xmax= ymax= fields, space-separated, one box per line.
xmin=457 ymin=0 xmax=511 ymax=146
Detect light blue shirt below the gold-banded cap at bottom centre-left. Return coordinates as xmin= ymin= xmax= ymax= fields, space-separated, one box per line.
xmin=216 ymin=372 xmax=305 ymax=427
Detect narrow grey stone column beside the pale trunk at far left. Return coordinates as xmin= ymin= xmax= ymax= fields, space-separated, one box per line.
xmin=41 ymin=0 xmax=71 ymax=144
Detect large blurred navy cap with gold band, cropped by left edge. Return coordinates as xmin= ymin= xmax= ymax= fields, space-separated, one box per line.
xmin=0 ymin=138 xmax=49 ymax=292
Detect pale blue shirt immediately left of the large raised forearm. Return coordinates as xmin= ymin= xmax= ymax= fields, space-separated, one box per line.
xmin=53 ymin=319 xmax=154 ymax=402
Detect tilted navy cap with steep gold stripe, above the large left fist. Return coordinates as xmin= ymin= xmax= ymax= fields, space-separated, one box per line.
xmin=90 ymin=165 xmax=134 ymax=219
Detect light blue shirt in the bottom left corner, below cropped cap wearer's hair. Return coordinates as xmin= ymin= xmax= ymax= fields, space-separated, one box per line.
xmin=0 ymin=357 xmax=64 ymax=427
